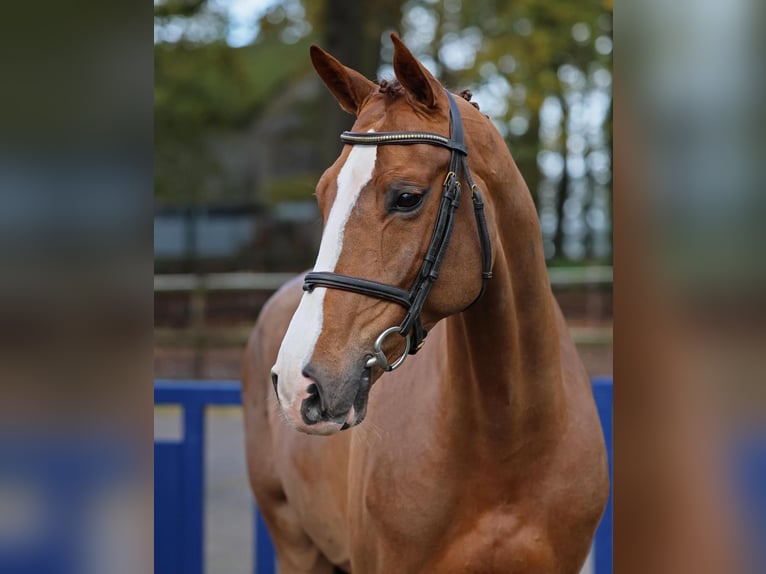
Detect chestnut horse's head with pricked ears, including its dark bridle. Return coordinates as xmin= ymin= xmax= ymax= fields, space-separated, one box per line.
xmin=272 ymin=35 xmax=495 ymax=434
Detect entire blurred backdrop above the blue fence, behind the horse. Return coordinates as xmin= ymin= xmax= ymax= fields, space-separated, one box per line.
xmin=154 ymin=0 xmax=613 ymax=379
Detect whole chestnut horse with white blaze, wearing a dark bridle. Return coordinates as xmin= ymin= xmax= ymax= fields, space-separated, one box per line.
xmin=243 ymin=35 xmax=608 ymax=574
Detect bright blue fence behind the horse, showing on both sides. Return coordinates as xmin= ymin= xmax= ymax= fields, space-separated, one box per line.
xmin=154 ymin=378 xmax=613 ymax=574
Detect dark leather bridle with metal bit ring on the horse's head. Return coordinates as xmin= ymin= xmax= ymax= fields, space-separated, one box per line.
xmin=303 ymin=90 xmax=492 ymax=371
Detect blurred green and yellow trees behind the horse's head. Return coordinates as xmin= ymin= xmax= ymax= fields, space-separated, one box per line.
xmin=155 ymin=0 xmax=612 ymax=261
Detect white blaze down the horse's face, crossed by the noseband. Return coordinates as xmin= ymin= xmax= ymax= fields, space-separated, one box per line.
xmin=273 ymin=130 xmax=377 ymax=420
